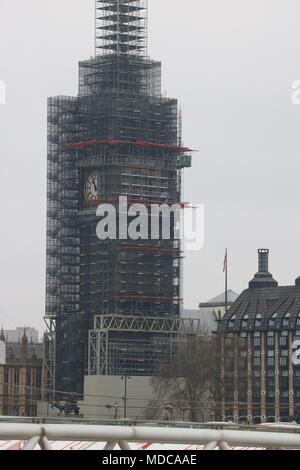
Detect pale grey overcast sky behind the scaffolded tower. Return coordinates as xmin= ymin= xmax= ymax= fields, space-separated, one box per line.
xmin=0 ymin=0 xmax=300 ymax=329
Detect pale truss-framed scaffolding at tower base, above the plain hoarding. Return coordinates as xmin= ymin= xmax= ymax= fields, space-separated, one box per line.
xmin=88 ymin=315 xmax=203 ymax=376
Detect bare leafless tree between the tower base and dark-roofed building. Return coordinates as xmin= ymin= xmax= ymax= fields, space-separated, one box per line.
xmin=147 ymin=330 xmax=218 ymax=421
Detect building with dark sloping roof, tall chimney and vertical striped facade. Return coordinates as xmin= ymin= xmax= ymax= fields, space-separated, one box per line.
xmin=218 ymin=250 xmax=300 ymax=422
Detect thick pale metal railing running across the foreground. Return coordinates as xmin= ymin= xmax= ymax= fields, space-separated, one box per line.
xmin=0 ymin=423 xmax=300 ymax=450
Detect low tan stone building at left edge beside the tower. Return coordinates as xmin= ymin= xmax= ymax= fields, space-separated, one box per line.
xmin=0 ymin=330 xmax=43 ymax=416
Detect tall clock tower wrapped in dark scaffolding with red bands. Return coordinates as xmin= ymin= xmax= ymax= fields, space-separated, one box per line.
xmin=45 ymin=0 xmax=190 ymax=393
